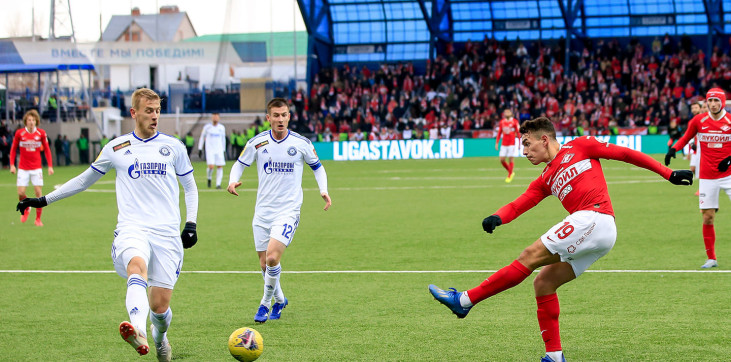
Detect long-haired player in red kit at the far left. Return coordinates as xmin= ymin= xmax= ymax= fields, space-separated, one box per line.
xmin=10 ymin=109 xmax=53 ymax=226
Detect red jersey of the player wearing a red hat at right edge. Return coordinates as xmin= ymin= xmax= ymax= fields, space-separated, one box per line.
xmin=673 ymin=110 xmax=731 ymax=180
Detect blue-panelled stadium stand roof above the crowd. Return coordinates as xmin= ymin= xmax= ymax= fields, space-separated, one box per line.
xmin=298 ymin=0 xmax=731 ymax=77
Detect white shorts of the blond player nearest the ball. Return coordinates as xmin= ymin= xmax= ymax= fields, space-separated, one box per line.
xmin=112 ymin=229 xmax=183 ymax=289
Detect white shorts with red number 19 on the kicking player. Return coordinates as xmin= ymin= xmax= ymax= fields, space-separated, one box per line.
xmin=541 ymin=211 xmax=617 ymax=277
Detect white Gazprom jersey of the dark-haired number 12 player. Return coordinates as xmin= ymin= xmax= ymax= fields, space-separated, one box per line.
xmin=238 ymin=131 xmax=322 ymax=221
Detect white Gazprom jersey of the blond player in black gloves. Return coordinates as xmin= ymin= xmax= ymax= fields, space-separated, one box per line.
xmin=91 ymin=132 xmax=193 ymax=236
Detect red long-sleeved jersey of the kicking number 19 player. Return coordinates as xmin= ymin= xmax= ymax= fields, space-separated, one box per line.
xmin=495 ymin=136 xmax=673 ymax=224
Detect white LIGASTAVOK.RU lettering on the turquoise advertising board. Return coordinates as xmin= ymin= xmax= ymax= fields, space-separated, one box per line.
xmin=333 ymin=139 xmax=464 ymax=161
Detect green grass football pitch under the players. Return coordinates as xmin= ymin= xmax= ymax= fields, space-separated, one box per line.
xmin=0 ymin=155 xmax=731 ymax=361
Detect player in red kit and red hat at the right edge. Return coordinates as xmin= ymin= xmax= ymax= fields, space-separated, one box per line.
xmin=665 ymin=88 xmax=731 ymax=269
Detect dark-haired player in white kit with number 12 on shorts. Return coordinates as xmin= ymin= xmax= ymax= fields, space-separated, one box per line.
xmin=227 ymin=98 xmax=332 ymax=323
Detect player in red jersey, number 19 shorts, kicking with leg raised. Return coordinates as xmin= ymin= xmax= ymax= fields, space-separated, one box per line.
xmin=429 ymin=117 xmax=693 ymax=362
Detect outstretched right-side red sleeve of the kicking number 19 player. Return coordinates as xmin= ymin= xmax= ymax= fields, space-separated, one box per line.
xmin=580 ymin=137 xmax=673 ymax=180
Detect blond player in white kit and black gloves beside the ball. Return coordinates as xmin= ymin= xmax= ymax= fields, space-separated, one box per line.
xmin=17 ymin=88 xmax=198 ymax=361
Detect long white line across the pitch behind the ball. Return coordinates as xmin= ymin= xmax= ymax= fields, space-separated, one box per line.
xmin=0 ymin=269 xmax=731 ymax=274
